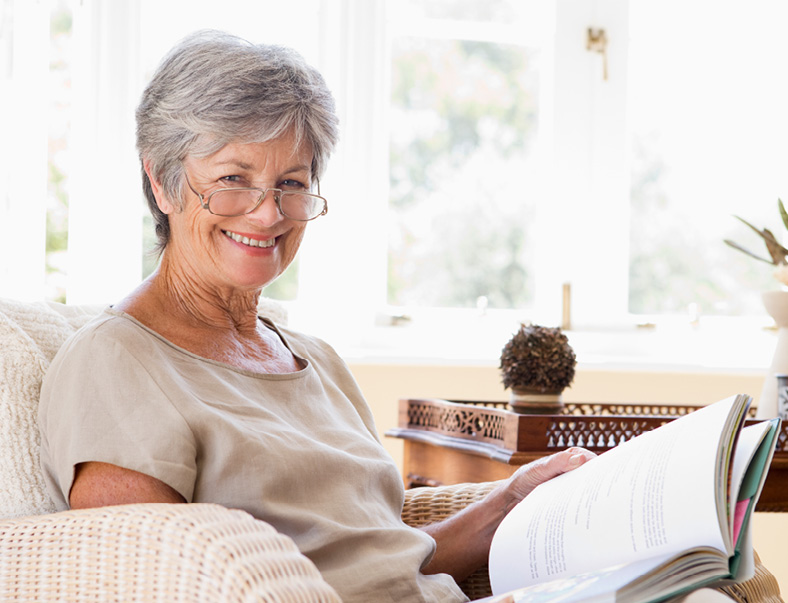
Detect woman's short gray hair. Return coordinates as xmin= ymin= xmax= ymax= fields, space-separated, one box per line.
xmin=137 ymin=30 xmax=338 ymax=252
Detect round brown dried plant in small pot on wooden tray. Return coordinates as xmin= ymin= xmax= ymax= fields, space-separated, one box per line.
xmin=500 ymin=325 xmax=577 ymax=414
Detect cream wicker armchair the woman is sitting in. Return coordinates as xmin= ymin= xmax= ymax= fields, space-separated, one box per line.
xmin=0 ymin=299 xmax=782 ymax=603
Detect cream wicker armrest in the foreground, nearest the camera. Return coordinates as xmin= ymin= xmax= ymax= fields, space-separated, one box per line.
xmin=0 ymin=504 xmax=339 ymax=603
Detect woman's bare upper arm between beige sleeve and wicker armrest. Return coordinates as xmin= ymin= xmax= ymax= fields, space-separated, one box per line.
xmin=69 ymin=461 xmax=186 ymax=509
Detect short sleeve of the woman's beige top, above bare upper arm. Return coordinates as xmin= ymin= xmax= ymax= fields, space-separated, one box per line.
xmin=39 ymin=317 xmax=197 ymax=509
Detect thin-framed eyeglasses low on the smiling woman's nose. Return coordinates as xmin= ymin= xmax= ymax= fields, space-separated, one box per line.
xmin=183 ymin=170 xmax=328 ymax=222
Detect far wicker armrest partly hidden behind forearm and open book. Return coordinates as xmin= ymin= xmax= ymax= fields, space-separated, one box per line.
xmin=402 ymin=482 xmax=784 ymax=603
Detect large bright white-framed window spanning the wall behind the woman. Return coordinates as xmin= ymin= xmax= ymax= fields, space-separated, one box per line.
xmin=0 ymin=0 xmax=788 ymax=364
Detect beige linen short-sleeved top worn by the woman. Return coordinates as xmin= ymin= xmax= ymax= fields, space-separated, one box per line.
xmin=39 ymin=308 xmax=466 ymax=603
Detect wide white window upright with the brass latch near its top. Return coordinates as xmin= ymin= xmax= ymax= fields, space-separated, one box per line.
xmin=536 ymin=0 xmax=629 ymax=326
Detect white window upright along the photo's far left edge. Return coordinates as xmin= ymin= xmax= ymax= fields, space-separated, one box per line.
xmin=0 ymin=0 xmax=49 ymax=300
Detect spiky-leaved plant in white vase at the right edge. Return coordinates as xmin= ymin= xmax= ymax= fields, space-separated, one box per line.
xmin=725 ymin=199 xmax=788 ymax=419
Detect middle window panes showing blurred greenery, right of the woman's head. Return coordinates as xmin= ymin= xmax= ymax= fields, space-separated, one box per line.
xmin=388 ymin=1 xmax=539 ymax=308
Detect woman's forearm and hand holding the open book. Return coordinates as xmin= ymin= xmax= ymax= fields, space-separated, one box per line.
xmin=421 ymin=448 xmax=596 ymax=581
